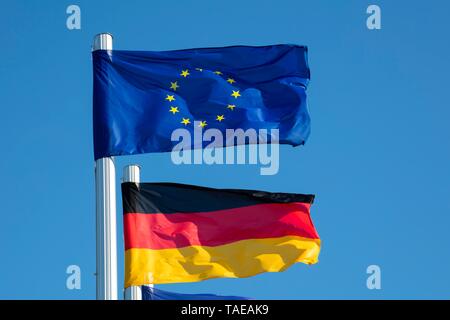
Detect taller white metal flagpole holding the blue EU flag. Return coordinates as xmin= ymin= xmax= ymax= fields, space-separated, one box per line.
xmin=92 ymin=33 xmax=117 ymax=300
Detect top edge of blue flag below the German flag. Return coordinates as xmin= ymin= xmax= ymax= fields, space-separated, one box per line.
xmin=141 ymin=286 xmax=250 ymax=300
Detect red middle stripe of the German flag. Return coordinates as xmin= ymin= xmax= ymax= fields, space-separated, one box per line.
xmin=124 ymin=202 xmax=319 ymax=249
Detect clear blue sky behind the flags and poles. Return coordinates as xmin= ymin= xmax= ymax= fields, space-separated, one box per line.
xmin=0 ymin=0 xmax=450 ymax=299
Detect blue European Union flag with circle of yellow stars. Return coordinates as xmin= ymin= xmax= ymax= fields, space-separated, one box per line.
xmin=92 ymin=45 xmax=310 ymax=159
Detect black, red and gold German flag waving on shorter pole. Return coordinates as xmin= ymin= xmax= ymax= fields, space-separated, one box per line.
xmin=122 ymin=182 xmax=320 ymax=287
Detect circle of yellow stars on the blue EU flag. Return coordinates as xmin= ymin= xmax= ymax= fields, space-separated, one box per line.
xmin=165 ymin=68 xmax=241 ymax=128
